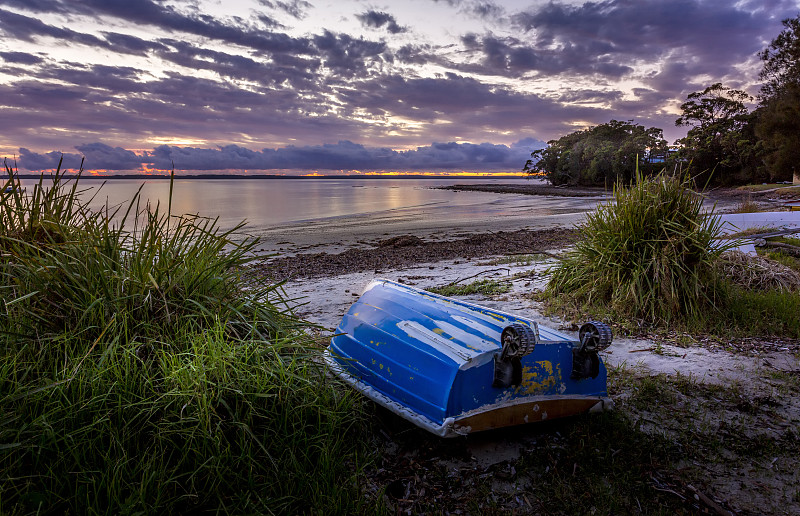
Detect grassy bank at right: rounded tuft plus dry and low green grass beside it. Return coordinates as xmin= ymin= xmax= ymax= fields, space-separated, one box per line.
xmin=543 ymin=171 xmax=800 ymax=338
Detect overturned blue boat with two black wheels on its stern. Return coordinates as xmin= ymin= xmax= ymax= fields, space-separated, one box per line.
xmin=326 ymin=280 xmax=613 ymax=437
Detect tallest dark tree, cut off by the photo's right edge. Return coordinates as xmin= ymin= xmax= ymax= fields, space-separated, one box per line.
xmin=756 ymin=15 xmax=800 ymax=181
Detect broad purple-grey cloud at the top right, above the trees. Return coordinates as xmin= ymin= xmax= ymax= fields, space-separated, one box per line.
xmin=514 ymin=0 xmax=768 ymax=80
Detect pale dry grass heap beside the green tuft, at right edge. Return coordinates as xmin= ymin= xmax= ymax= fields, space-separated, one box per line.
xmin=716 ymin=251 xmax=800 ymax=291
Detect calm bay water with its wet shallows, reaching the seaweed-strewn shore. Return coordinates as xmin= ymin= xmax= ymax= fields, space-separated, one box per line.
xmin=15 ymin=178 xmax=598 ymax=253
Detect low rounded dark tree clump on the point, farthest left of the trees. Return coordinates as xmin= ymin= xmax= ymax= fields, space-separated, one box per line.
xmin=523 ymin=120 xmax=667 ymax=186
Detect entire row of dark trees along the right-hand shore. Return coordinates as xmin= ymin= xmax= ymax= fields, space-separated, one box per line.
xmin=523 ymin=15 xmax=800 ymax=186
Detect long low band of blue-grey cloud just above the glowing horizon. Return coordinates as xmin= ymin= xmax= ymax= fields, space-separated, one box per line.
xmin=19 ymin=138 xmax=545 ymax=172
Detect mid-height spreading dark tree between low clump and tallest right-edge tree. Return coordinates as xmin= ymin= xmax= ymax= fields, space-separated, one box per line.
xmin=675 ymin=83 xmax=760 ymax=183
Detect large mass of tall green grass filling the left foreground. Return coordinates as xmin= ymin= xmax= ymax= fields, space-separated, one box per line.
xmin=0 ymin=161 xmax=365 ymax=514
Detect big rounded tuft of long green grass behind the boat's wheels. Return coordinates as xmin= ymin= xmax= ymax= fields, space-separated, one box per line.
xmin=545 ymin=174 xmax=725 ymax=324
